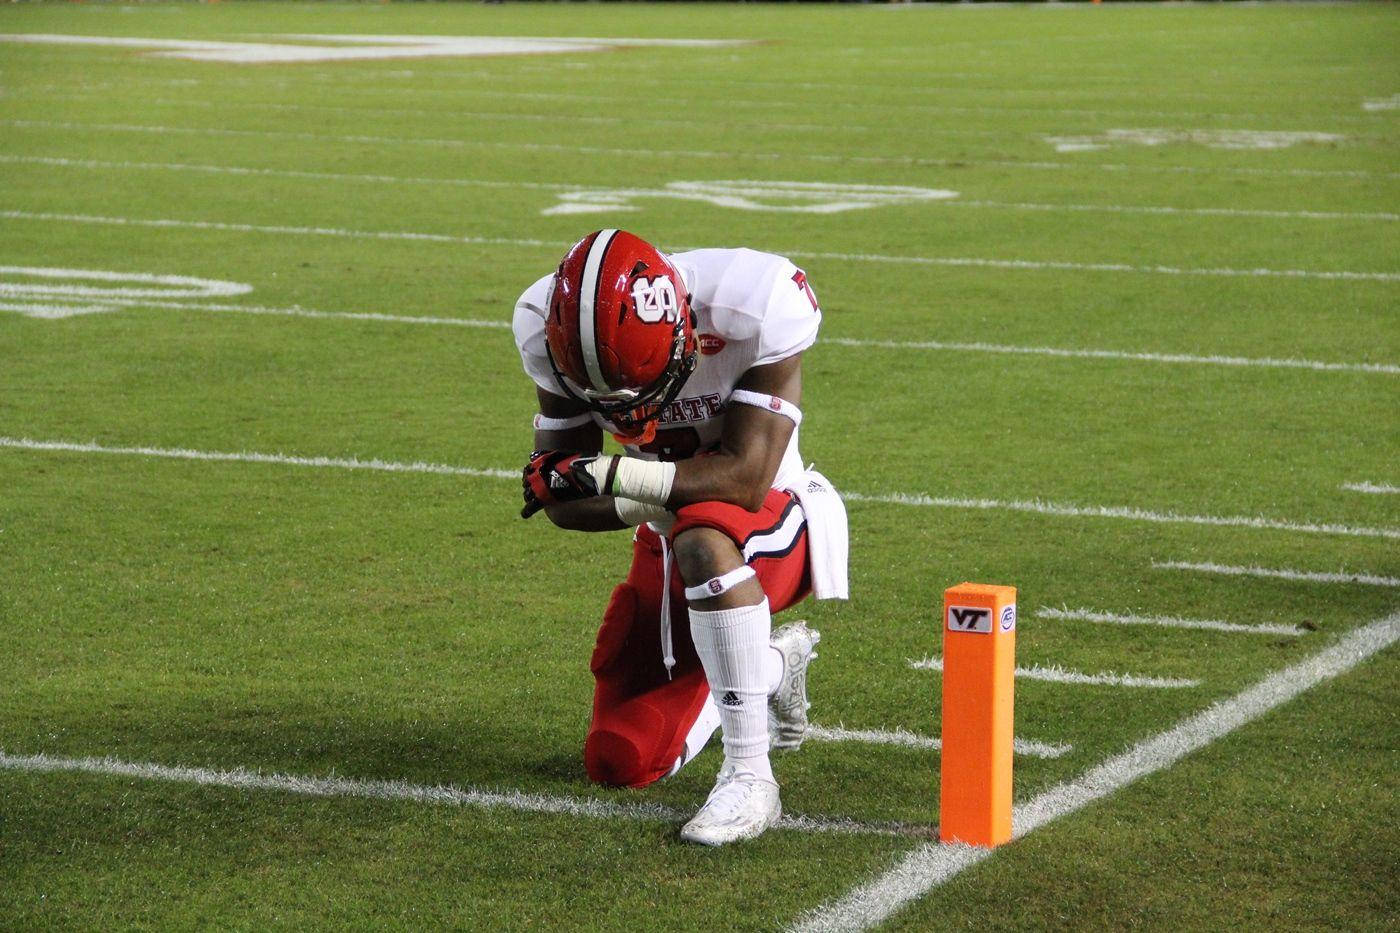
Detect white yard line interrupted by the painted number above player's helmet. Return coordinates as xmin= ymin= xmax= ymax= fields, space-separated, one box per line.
xmin=0 ymin=155 xmax=1400 ymax=221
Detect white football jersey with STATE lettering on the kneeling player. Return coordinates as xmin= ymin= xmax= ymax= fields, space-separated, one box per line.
xmin=514 ymin=243 xmax=822 ymax=488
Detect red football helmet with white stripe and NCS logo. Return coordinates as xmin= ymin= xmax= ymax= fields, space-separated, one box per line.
xmin=545 ymin=230 xmax=697 ymax=444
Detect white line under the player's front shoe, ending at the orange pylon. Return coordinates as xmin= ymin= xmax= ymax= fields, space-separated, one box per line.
xmin=0 ymin=751 xmax=907 ymax=835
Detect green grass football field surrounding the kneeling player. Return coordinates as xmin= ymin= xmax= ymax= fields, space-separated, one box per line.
xmin=0 ymin=3 xmax=1400 ymax=930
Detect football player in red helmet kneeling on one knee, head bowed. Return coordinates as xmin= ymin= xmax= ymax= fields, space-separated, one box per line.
xmin=514 ymin=230 xmax=847 ymax=845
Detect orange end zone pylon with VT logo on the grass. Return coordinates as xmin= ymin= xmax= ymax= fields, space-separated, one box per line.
xmin=938 ymin=583 xmax=1016 ymax=846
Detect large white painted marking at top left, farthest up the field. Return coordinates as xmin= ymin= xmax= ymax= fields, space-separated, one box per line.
xmin=0 ymin=32 xmax=752 ymax=64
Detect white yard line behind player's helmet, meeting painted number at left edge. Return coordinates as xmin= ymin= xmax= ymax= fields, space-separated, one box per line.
xmin=8 ymin=286 xmax=1400 ymax=378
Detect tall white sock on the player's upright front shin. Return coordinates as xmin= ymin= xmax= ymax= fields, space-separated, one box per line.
xmin=690 ymin=600 xmax=773 ymax=780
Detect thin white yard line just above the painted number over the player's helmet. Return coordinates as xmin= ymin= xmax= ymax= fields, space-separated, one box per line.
xmin=8 ymin=119 xmax=1400 ymax=178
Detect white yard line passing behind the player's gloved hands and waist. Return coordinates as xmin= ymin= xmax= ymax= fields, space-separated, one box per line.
xmin=0 ymin=436 xmax=1400 ymax=540
